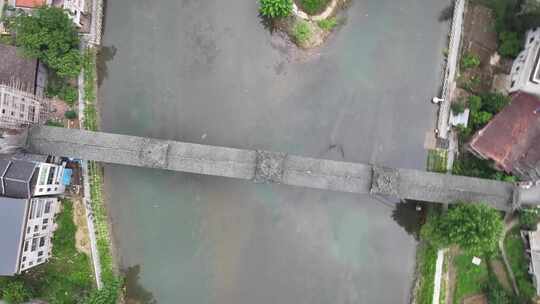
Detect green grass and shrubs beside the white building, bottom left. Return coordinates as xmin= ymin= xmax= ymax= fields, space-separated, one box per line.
xmin=0 ymin=200 xmax=93 ymax=303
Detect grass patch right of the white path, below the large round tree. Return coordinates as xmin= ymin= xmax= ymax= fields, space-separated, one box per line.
xmin=454 ymin=254 xmax=489 ymax=304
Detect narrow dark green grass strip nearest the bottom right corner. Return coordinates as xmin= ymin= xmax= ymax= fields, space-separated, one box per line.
xmin=504 ymin=228 xmax=536 ymax=299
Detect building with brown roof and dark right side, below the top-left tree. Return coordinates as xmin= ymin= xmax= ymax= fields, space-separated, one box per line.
xmin=0 ymin=44 xmax=47 ymax=97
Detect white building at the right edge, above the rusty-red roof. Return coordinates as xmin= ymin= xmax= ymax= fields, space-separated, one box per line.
xmin=508 ymin=28 xmax=540 ymax=96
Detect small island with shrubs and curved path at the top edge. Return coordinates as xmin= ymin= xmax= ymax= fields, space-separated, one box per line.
xmin=259 ymin=0 xmax=347 ymax=49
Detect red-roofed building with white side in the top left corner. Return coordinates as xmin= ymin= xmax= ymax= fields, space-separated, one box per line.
xmin=8 ymin=0 xmax=86 ymax=28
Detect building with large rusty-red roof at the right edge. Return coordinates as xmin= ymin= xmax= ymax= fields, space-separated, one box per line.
xmin=468 ymin=92 xmax=540 ymax=180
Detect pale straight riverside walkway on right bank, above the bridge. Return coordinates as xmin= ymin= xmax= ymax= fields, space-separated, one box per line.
xmin=437 ymin=0 xmax=466 ymax=139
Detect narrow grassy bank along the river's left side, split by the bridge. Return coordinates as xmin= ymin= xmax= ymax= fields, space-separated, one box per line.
xmin=83 ymin=49 xmax=122 ymax=304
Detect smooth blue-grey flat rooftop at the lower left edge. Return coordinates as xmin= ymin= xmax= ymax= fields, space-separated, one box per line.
xmin=0 ymin=197 xmax=27 ymax=276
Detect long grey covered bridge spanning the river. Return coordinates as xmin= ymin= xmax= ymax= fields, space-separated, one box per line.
xmin=12 ymin=126 xmax=540 ymax=211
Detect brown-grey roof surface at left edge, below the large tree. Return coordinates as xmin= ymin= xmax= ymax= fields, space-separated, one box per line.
xmin=0 ymin=44 xmax=38 ymax=93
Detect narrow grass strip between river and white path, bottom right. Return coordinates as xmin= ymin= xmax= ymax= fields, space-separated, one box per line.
xmin=416 ymin=242 xmax=437 ymax=304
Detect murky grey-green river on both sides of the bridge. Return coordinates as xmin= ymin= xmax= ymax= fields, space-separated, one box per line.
xmin=100 ymin=0 xmax=449 ymax=304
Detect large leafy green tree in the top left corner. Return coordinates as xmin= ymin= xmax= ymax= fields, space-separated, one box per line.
xmin=8 ymin=7 xmax=81 ymax=77
